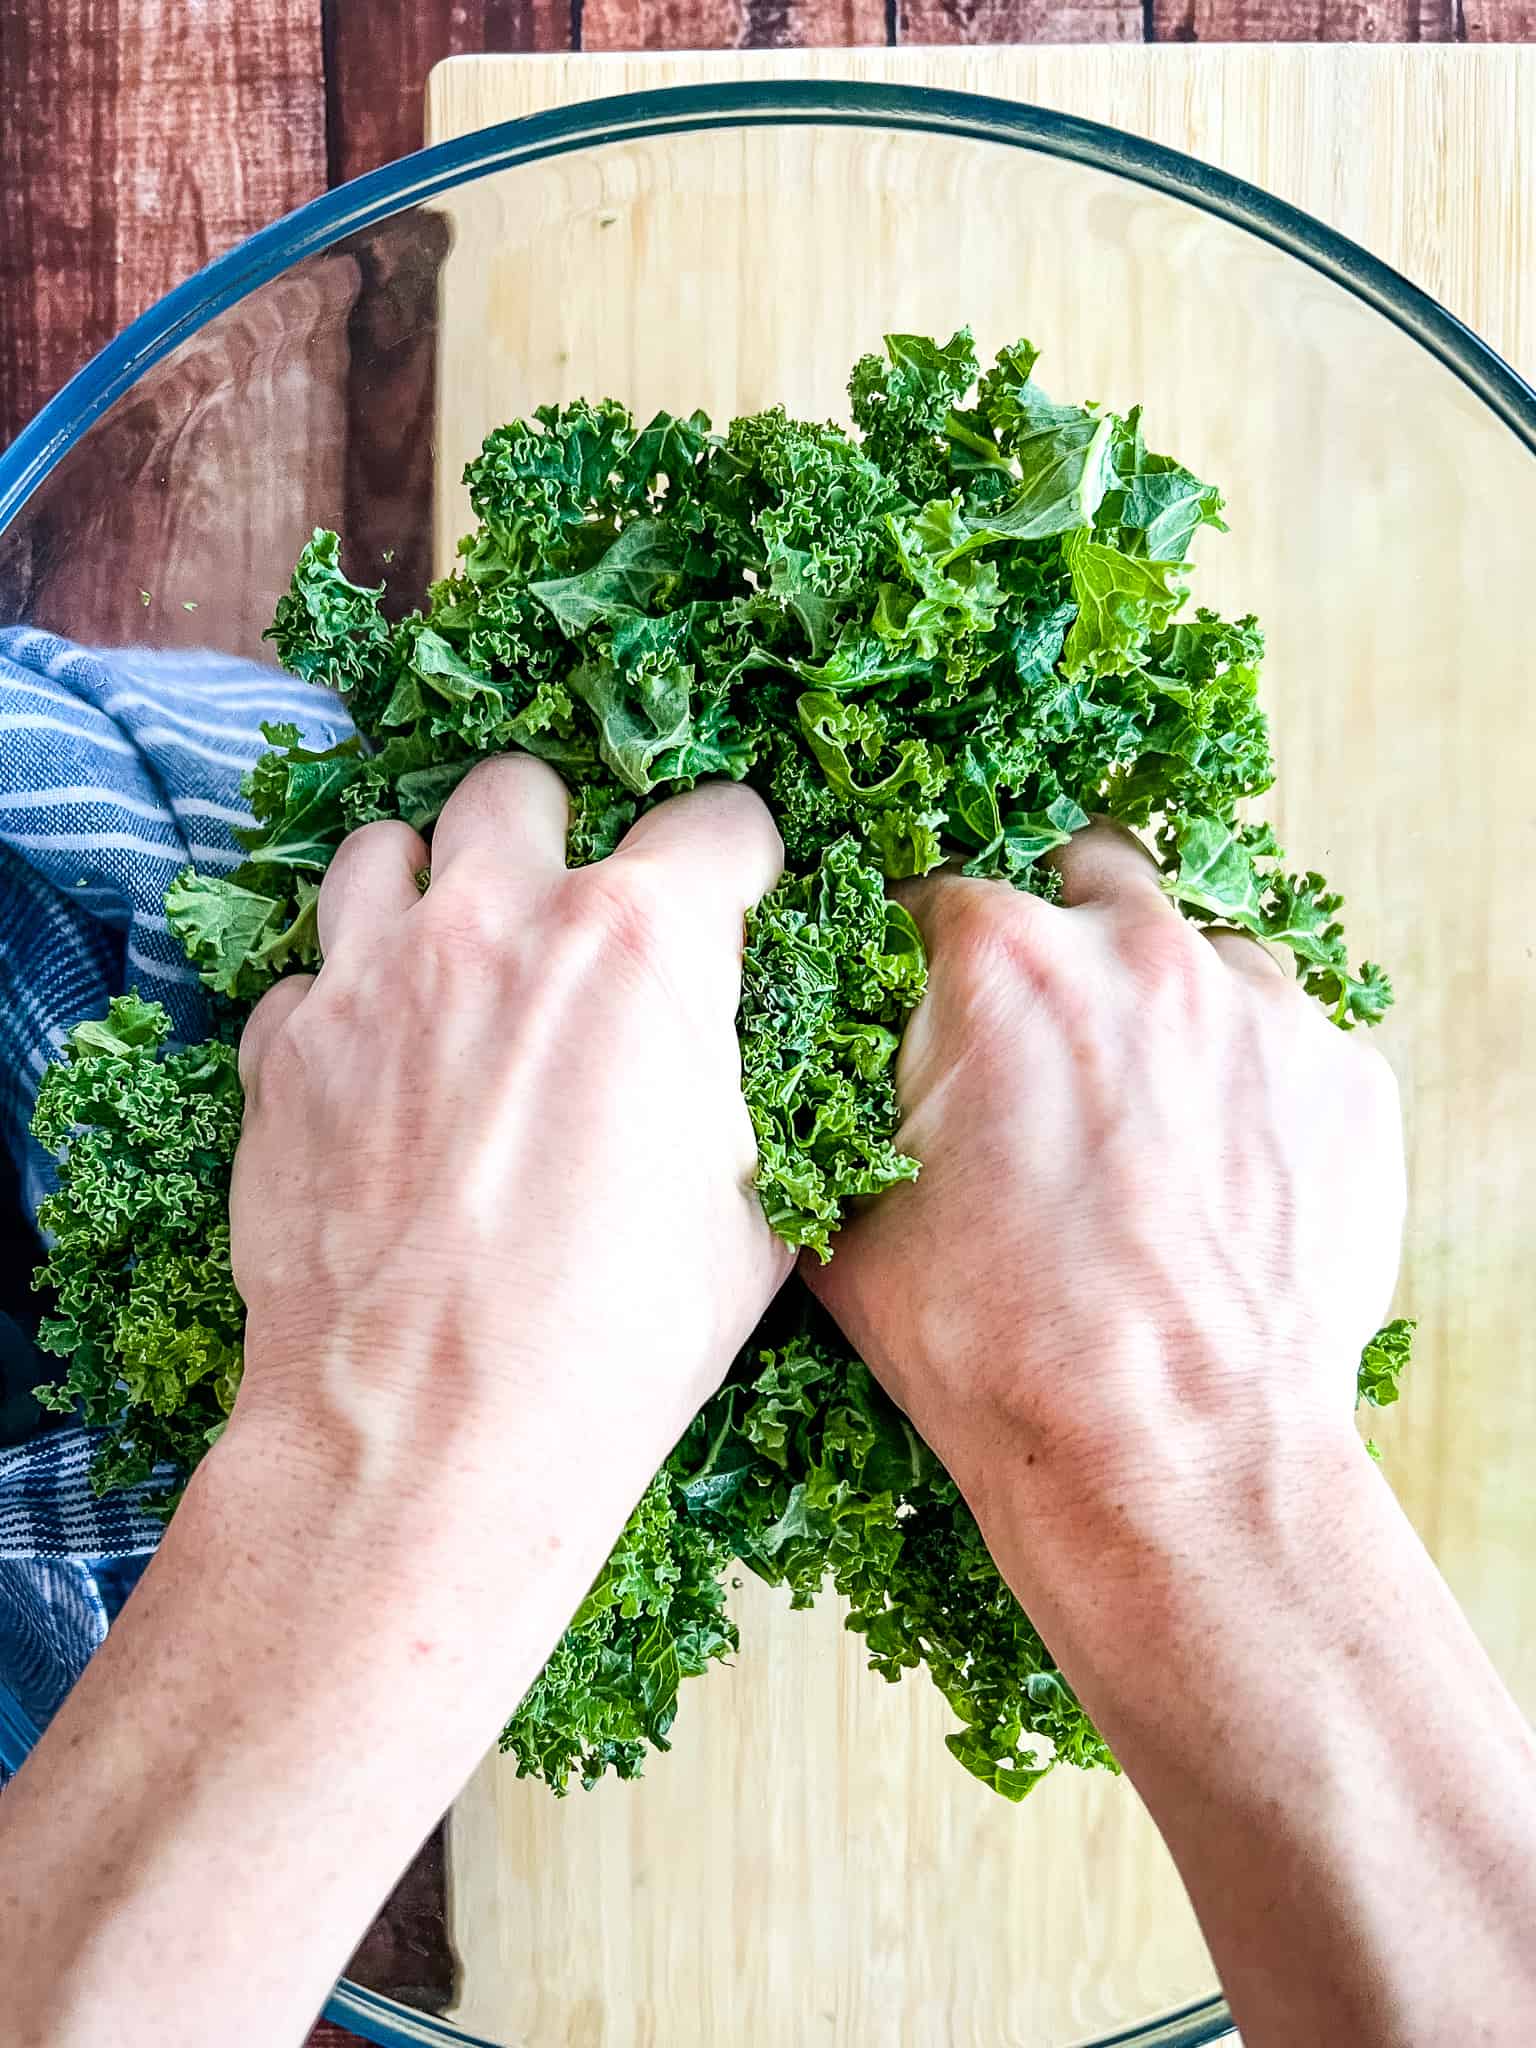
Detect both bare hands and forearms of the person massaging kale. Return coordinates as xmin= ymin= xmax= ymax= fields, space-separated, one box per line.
xmin=0 ymin=794 xmax=1536 ymax=2048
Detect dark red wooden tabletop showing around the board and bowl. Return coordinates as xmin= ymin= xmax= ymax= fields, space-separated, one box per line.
xmin=0 ymin=0 xmax=1536 ymax=2048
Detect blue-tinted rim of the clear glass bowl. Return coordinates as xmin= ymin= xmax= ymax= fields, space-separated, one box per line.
xmin=0 ymin=80 xmax=1536 ymax=2048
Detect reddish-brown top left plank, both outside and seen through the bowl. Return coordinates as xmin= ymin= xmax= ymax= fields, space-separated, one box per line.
xmin=0 ymin=0 xmax=350 ymax=653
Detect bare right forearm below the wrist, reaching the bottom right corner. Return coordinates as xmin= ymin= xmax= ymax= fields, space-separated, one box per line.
xmin=975 ymin=1425 xmax=1536 ymax=2048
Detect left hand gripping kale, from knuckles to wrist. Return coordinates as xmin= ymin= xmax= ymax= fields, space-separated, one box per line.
xmin=229 ymin=756 xmax=788 ymax=1505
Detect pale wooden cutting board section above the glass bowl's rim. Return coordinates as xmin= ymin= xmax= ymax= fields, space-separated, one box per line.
xmin=426 ymin=43 xmax=1536 ymax=379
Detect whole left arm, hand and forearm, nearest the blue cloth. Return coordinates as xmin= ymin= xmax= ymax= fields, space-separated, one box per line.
xmin=0 ymin=758 xmax=791 ymax=2048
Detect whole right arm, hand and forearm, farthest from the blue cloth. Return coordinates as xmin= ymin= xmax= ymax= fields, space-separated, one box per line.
xmin=811 ymin=827 xmax=1536 ymax=2048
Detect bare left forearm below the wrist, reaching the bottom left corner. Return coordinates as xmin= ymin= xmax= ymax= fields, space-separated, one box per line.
xmin=0 ymin=1376 xmax=643 ymax=2048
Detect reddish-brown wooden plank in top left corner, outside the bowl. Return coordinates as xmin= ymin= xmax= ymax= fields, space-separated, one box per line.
xmin=0 ymin=0 xmax=326 ymax=440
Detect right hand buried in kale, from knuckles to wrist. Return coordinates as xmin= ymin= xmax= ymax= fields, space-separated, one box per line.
xmin=807 ymin=825 xmax=1405 ymax=1511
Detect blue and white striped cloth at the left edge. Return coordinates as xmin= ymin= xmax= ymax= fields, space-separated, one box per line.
xmin=0 ymin=627 xmax=350 ymax=1776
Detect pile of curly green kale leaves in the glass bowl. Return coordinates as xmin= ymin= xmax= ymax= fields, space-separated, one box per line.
xmin=37 ymin=332 xmax=1407 ymax=1798
